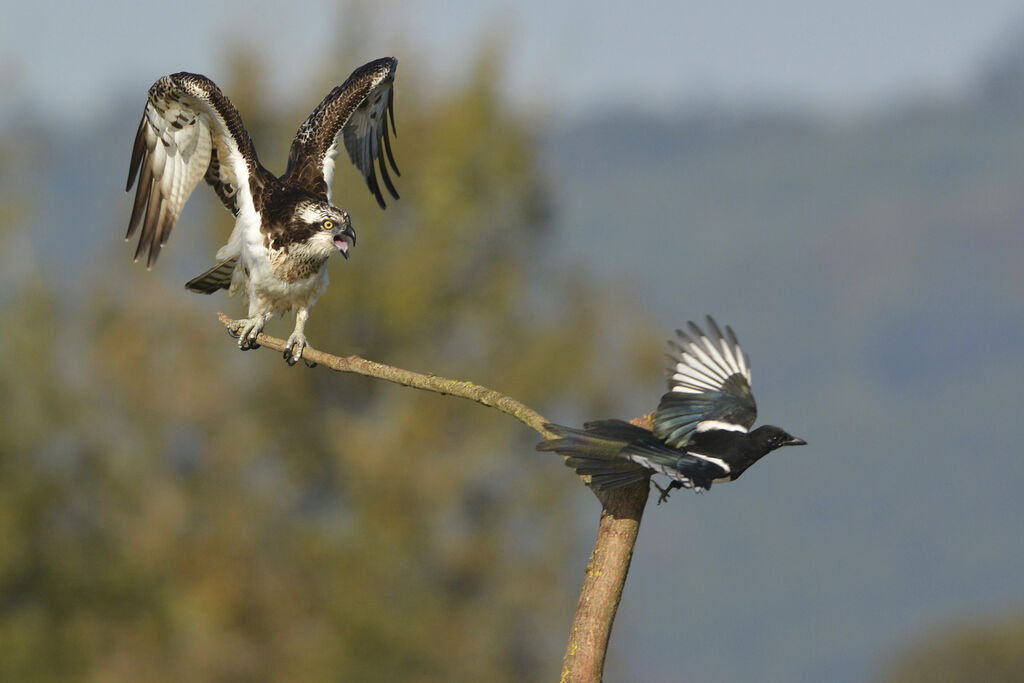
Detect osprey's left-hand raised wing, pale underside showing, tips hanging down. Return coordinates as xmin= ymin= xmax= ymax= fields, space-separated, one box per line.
xmin=125 ymin=72 xmax=268 ymax=267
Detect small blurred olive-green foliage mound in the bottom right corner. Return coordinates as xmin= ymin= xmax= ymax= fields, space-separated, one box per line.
xmin=882 ymin=609 xmax=1024 ymax=683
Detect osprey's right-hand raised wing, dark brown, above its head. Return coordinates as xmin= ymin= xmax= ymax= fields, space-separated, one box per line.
xmin=285 ymin=57 xmax=400 ymax=209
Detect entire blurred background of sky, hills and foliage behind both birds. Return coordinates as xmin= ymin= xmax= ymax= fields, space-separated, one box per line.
xmin=0 ymin=0 xmax=1024 ymax=682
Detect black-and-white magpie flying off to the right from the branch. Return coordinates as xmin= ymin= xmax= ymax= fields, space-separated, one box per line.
xmin=537 ymin=315 xmax=807 ymax=504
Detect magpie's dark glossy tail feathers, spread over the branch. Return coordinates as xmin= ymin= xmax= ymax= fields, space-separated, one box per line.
xmin=537 ymin=420 xmax=651 ymax=492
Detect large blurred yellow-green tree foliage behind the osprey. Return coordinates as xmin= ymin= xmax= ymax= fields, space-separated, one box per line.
xmin=0 ymin=44 xmax=658 ymax=681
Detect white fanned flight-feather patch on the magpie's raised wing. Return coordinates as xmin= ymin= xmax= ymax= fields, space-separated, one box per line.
xmin=669 ymin=315 xmax=751 ymax=393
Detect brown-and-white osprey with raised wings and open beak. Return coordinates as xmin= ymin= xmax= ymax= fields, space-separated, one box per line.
xmin=126 ymin=57 xmax=398 ymax=365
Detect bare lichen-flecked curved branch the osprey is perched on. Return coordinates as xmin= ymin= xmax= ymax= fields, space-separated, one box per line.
xmin=218 ymin=313 xmax=650 ymax=683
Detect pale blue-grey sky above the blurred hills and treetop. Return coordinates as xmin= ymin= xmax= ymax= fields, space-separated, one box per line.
xmin=0 ymin=0 xmax=1024 ymax=120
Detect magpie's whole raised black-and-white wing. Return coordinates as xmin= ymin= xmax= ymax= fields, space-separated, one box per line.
xmin=653 ymin=315 xmax=757 ymax=451
